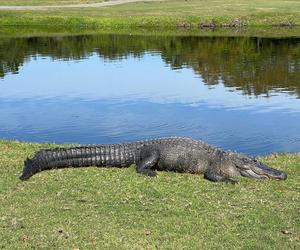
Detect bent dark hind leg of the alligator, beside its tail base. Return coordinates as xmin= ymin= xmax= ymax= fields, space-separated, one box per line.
xmin=136 ymin=150 xmax=159 ymax=177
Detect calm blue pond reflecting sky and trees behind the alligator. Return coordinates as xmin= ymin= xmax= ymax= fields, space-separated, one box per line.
xmin=0 ymin=35 xmax=300 ymax=155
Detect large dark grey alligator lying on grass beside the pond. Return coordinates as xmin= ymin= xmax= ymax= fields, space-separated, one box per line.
xmin=20 ymin=137 xmax=287 ymax=184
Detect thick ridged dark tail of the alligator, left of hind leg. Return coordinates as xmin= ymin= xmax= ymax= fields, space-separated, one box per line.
xmin=20 ymin=144 xmax=135 ymax=181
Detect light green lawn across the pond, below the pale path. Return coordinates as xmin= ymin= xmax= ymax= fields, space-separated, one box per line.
xmin=0 ymin=0 xmax=300 ymax=29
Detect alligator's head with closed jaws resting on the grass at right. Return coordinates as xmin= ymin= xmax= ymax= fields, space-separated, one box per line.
xmin=231 ymin=154 xmax=287 ymax=180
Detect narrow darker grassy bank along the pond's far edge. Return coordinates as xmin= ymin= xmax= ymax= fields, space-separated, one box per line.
xmin=0 ymin=25 xmax=300 ymax=38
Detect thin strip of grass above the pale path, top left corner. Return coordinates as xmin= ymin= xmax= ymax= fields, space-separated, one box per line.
xmin=0 ymin=0 xmax=105 ymax=6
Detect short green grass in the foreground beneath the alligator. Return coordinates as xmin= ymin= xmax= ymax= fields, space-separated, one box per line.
xmin=0 ymin=141 xmax=300 ymax=249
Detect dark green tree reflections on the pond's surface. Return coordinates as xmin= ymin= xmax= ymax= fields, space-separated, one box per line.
xmin=0 ymin=35 xmax=300 ymax=97
